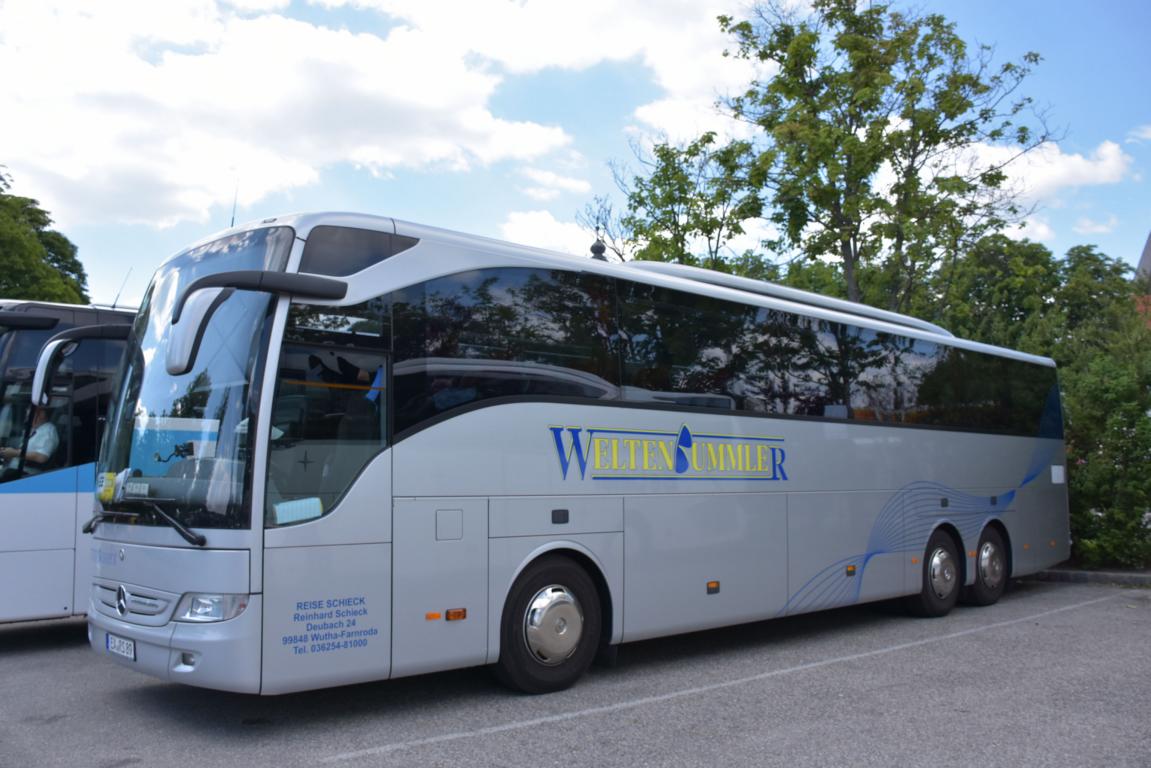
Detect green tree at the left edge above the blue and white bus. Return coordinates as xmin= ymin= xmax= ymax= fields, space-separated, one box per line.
xmin=0 ymin=172 xmax=89 ymax=304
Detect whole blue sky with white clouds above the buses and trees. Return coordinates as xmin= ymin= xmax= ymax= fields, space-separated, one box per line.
xmin=0 ymin=0 xmax=1151 ymax=304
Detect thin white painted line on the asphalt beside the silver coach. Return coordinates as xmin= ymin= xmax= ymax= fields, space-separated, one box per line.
xmin=320 ymin=594 xmax=1122 ymax=762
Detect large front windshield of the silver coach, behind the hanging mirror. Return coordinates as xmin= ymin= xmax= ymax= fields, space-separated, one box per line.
xmin=97 ymin=227 xmax=294 ymax=529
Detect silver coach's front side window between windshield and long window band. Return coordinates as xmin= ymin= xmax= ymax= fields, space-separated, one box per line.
xmin=265 ymin=302 xmax=388 ymax=527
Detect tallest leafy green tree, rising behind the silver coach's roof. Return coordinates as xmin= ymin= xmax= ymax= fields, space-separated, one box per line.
xmin=721 ymin=0 xmax=1049 ymax=311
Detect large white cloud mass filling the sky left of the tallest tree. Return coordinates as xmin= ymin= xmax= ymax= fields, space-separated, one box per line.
xmin=0 ymin=0 xmax=752 ymax=225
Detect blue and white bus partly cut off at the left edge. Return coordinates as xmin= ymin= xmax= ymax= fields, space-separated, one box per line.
xmin=0 ymin=299 xmax=135 ymax=622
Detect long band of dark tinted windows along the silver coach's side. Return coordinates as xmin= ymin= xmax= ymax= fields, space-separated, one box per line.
xmin=388 ymin=268 xmax=1053 ymax=433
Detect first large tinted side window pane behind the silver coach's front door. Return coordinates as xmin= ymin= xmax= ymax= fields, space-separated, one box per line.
xmin=390 ymin=268 xmax=619 ymax=432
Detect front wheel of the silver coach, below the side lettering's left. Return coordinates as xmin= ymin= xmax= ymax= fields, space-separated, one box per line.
xmin=495 ymin=555 xmax=602 ymax=693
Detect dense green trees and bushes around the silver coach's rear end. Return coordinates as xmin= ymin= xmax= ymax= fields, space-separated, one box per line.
xmin=939 ymin=236 xmax=1151 ymax=567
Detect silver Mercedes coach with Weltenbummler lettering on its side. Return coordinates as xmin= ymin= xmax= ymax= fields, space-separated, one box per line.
xmin=89 ymin=214 xmax=1069 ymax=694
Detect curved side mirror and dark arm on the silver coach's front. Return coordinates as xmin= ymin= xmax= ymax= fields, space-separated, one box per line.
xmin=165 ymin=269 xmax=348 ymax=377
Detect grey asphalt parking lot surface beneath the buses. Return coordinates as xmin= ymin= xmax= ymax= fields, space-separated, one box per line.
xmin=0 ymin=580 xmax=1151 ymax=768
